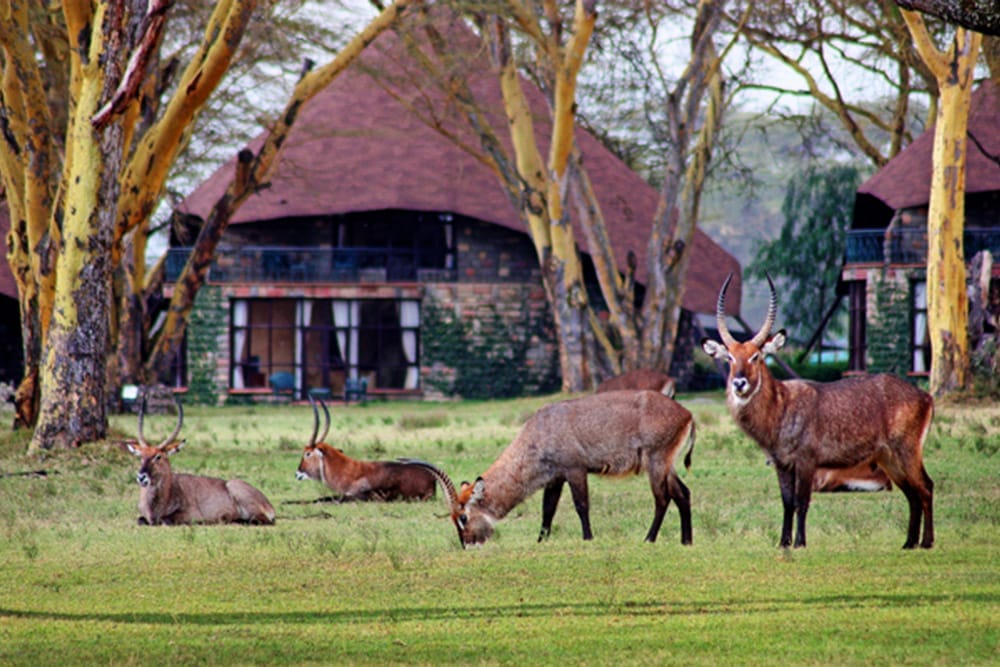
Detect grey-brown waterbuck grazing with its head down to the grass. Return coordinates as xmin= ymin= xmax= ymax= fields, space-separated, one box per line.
xmin=402 ymin=391 xmax=694 ymax=548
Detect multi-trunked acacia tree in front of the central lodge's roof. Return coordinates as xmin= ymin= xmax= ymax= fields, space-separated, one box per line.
xmin=390 ymin=0 xmax=725 ymax=391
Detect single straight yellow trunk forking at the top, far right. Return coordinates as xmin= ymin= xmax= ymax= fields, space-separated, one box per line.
xmin=903 ymin=11 xmax=981 ymax=396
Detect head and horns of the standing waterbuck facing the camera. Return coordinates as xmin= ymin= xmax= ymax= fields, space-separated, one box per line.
xmin=701 ymin=273 xmax=786 ymax=405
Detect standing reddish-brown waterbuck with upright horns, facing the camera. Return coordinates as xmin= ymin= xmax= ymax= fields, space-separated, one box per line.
xmin=701 ymin=274 xmax=934 ymax=549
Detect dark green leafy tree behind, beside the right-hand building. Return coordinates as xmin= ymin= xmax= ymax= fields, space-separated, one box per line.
xmin=747 ymin=166 xmax=860 ymax=338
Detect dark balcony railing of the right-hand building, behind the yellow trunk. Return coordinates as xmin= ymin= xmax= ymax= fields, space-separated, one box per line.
xmin=847 ymin=228 xmax=1000 ymax=264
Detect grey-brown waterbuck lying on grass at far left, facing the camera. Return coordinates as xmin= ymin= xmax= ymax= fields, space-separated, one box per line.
xmin=127 ymin=395 xmax=274 ymax=526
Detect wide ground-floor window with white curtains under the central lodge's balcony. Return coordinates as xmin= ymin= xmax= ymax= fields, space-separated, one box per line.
xmin=230 ymin=299 xmax=420 ymax=396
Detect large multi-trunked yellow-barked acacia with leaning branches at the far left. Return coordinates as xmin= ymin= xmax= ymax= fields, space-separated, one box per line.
xmin=0 ymin=0 xmax=410 ymax=449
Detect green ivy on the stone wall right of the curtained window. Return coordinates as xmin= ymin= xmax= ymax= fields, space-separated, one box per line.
xmin=421 ymin=299 xmax=558 ymax=399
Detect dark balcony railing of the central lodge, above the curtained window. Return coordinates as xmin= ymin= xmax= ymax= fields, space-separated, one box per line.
xmin=166 ymin=247 xmax=457 ymax=283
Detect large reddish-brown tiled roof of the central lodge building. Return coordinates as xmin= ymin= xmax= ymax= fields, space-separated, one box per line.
xmin=180 ymin=18 xmax=741 ymax=314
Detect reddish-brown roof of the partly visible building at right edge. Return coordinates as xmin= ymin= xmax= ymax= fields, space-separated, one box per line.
xmin=858 ymin=80 xmax=1000 ymax=210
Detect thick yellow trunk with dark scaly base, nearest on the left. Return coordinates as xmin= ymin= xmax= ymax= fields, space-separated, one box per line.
xmin=29 ymin=5 xmax=123 ymax=452
